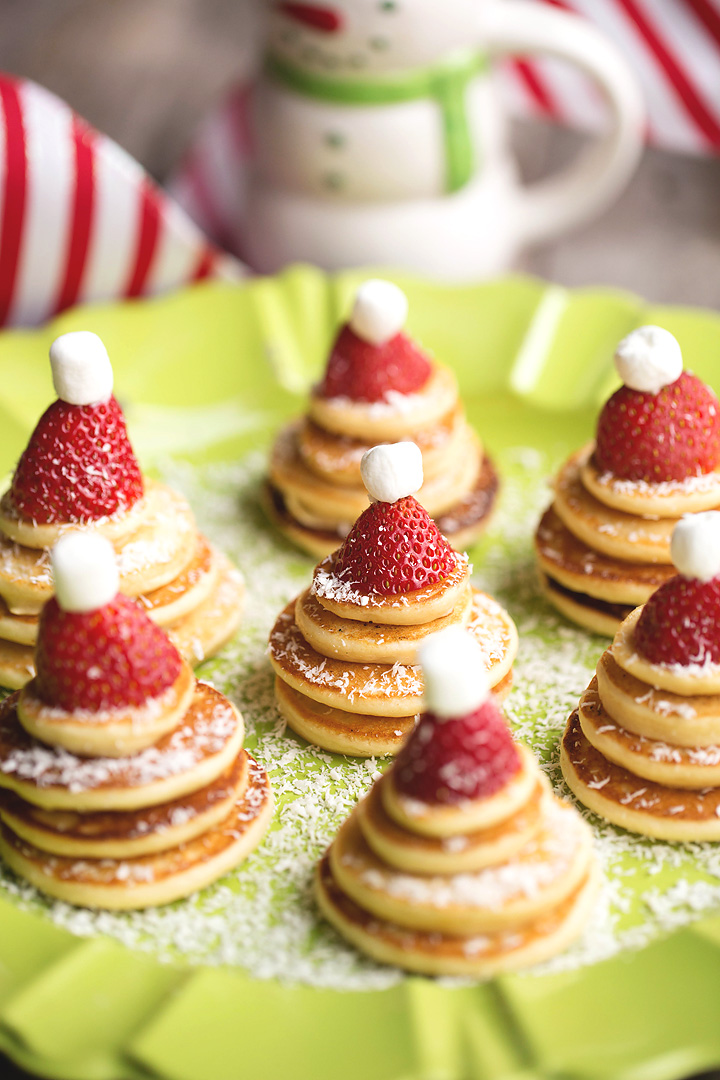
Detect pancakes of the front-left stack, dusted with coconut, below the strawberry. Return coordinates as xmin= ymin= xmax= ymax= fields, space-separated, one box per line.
xmin=0 ymin=536 xmax=272 ymax=909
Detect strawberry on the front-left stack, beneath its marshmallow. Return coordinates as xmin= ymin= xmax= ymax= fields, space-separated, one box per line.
xmin=36 ymin=593 xmax=182 ymax=713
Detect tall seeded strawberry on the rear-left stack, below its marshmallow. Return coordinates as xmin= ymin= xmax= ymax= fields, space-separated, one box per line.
xmin=10 ymin=396 xmax=142 ymax=525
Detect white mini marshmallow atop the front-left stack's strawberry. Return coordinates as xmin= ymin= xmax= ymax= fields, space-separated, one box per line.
xmin=51 ymin=532 xmax=120 ymax=611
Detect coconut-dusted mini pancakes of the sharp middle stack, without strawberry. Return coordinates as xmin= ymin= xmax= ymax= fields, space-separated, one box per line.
xmin=270 ymin=544 xmax=518 ymax=757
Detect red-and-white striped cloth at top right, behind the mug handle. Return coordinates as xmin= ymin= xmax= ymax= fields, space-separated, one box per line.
xmin=504 ymin=0 xmax=720 ymax=153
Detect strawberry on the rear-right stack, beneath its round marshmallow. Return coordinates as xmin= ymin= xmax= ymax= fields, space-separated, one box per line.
xmin=595 ymin=372 xmax=720 ymax=483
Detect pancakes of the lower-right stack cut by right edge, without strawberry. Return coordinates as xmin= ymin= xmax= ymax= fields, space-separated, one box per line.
xmin=560 ymin=609 xmax=720 ymax=840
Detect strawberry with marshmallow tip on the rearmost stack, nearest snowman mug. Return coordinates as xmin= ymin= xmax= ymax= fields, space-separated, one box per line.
xmin=318 ymin=280 xmax=432 ymax=402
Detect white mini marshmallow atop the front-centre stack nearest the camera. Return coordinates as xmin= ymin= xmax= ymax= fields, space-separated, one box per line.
xmin=418 ymin=626 xmax=490 ymax=719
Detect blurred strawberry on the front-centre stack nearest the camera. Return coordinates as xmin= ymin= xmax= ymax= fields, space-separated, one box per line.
xmin=393 ymin=698 xmax=520 ymax=804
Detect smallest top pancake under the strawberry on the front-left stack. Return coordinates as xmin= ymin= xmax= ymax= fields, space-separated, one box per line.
xmin=17 ymin=661 xmax=195 ymax=757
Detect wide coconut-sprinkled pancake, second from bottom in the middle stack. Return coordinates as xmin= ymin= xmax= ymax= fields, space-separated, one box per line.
xmin=270 ymin=590 xmax=517 ymax=717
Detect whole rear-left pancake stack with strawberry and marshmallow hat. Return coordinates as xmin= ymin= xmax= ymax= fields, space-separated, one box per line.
xmin=0 ymin=332 xmax=244 ymax=689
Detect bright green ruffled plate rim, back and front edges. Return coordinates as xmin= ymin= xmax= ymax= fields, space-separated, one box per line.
xmin=0 ymin=267 xmax=720 ymax=1080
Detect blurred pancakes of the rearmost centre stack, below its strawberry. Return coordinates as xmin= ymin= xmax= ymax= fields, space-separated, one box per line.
xmin=266 ymin=278 xmax=498 ymax=556
